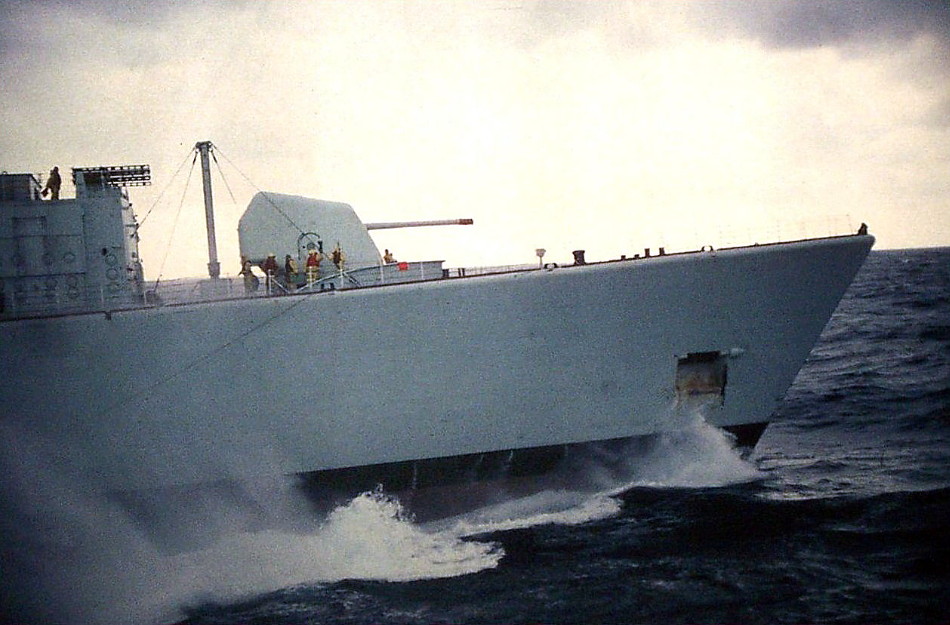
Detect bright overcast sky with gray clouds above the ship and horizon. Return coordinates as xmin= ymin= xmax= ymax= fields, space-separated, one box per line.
xmin=0 ymin=0 xmax=950 ymax=278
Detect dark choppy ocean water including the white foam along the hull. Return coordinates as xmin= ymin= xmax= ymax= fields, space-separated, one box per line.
xmin=167 ymin=248 xmax=950 ymax=625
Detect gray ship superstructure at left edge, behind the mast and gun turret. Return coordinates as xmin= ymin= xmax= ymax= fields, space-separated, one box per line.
xmin=0 ymin=165 xmax=150 ymax=317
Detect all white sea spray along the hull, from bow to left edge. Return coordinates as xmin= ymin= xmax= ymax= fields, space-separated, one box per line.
xmin=3 ymin=410 xmax=758 ymax=624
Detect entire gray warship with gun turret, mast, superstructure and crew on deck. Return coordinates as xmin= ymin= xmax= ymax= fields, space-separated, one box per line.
xmin=0 ymin=142 xmax=874 ymax=506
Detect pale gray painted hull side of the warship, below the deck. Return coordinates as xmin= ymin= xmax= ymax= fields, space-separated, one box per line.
xmin=0 ymin=236 xmax=873 ymax=500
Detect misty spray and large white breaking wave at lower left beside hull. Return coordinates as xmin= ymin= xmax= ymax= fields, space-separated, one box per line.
xmin=0 ymin=444 xmax=503 ymax=624
